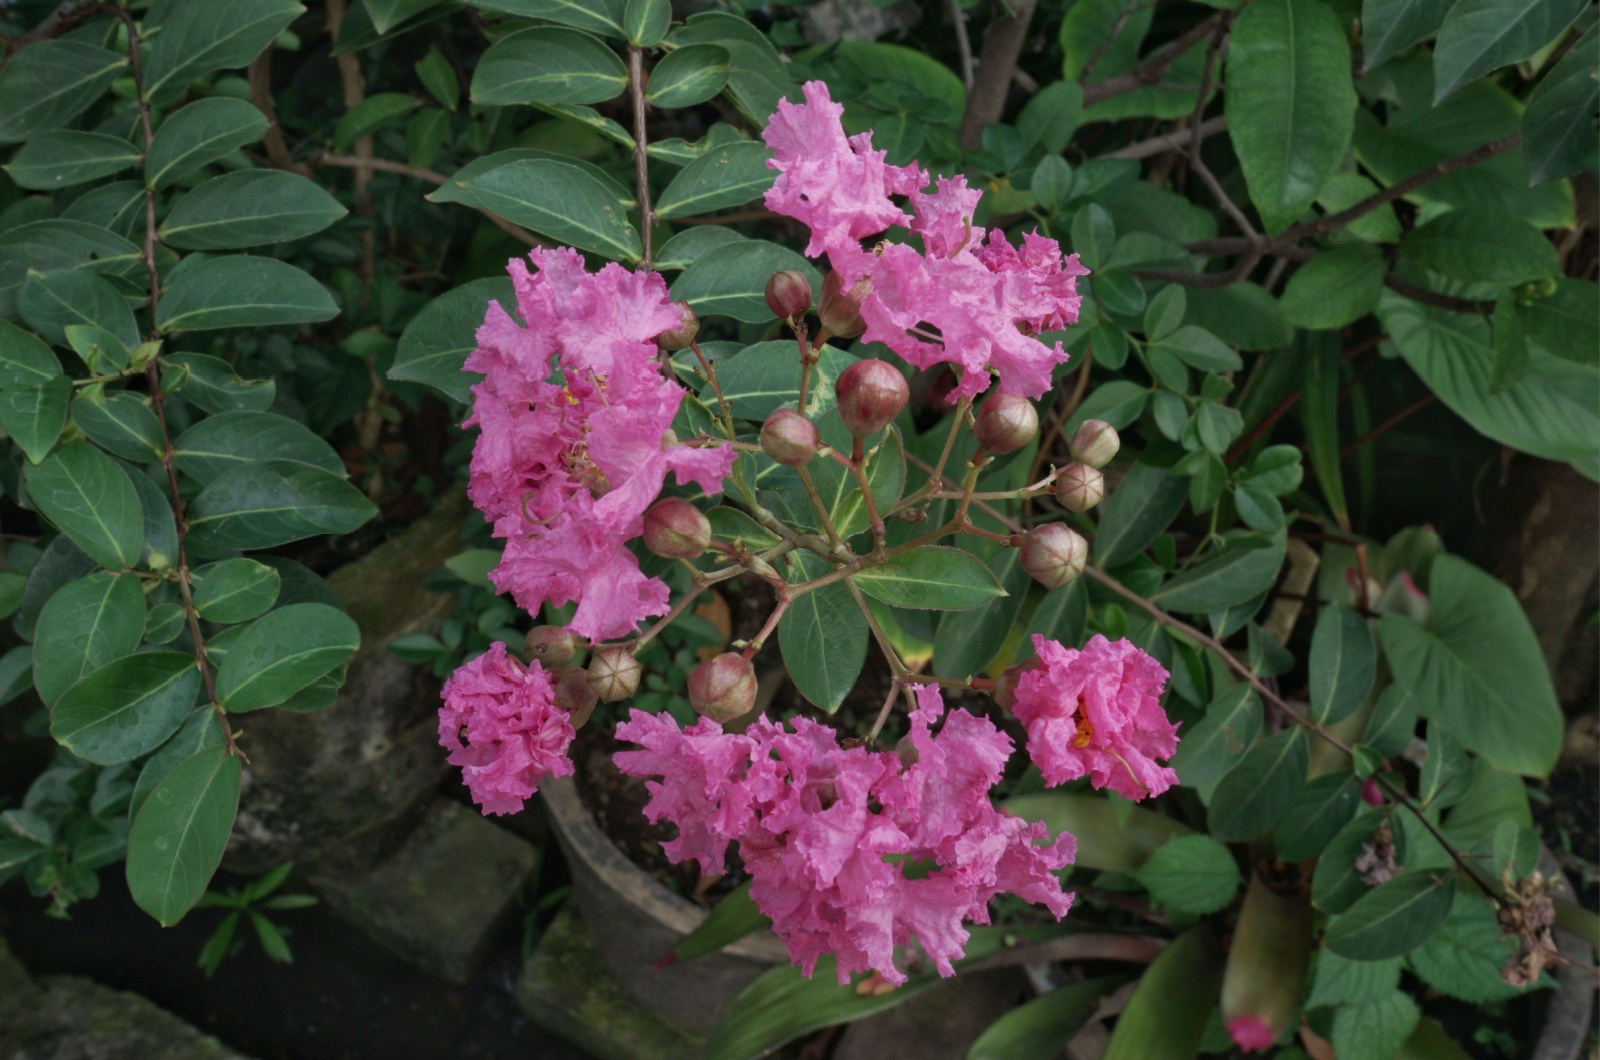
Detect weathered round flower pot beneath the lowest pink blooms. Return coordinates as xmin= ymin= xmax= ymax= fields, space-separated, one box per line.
xmin=539 ymin=777 xmax=789 ymax=1034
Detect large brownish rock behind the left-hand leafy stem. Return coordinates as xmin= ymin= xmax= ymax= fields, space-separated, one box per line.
xmin=222 ymin=492 xmax=467 ymax=876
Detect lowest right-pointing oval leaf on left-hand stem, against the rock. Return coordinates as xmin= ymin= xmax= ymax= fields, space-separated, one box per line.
xmin=216 ymin=604 xmax=362 ymax=714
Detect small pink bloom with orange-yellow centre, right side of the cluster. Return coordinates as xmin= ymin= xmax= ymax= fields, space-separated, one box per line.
xmin=1011 ymin=634 xmax=1178 ymax=801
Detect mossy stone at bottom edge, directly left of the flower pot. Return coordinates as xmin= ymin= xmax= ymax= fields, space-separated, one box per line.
xmin=517 ymin=901 xmax=704 ymax=1060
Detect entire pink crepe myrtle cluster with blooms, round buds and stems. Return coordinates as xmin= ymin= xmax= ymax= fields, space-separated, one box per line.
xmin=438 ymin=83 xmax=1178 ymax=983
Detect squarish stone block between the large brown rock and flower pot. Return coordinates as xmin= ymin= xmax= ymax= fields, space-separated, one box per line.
xmin=310 ymin=799 xmax=536 ymax=983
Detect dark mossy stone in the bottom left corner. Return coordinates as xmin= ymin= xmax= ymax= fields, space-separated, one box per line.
xmin=0 ymin=942 xmax=246 ymax=1060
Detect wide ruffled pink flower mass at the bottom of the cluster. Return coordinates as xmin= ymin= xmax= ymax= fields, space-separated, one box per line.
xmin=616 ymin=685 xmax=1075 ymax=983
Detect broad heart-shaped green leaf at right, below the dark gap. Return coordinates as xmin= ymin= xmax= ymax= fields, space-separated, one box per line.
xmin=1378 ymin=556 xmax=1562 ymax=777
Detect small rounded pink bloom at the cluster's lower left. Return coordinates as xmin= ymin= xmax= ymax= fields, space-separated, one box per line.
xmin=438 ymin=644 xmax=573 ymax=813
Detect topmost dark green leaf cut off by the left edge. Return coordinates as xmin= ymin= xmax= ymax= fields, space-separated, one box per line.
xmin=0 ymin=40 xmax=128 ymax=144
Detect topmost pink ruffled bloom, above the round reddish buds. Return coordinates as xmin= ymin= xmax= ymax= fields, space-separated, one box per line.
xmin=763 ymin=82 xmax=1088 ymax=397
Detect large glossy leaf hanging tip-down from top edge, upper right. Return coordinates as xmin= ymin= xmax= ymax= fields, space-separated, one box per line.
xmin=1222 ymin=0 xmax=1357 ymax=235
